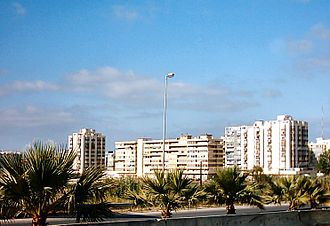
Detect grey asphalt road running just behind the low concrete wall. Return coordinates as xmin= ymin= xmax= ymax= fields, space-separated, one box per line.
xmin=0 ymin=205 xmax=288 ymax=226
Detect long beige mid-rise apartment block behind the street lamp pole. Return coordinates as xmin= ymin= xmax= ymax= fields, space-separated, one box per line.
xmin=115 ymin=134 xmax=224 ymax=180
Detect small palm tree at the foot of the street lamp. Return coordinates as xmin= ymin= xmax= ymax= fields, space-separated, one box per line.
xmin=142 ymin=170 xmax=192 ymax=218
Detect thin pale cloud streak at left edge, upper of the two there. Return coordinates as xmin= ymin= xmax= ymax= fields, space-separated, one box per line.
xmin=0 ymin=80 xmax=59 ymax=97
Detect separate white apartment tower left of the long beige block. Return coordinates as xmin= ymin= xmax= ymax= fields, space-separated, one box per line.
xmin=68 ymin=128 xmax=105 ymax=173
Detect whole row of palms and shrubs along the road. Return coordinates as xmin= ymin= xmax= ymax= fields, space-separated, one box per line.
xmin=0 ymin=142 xmax=330 ymax=226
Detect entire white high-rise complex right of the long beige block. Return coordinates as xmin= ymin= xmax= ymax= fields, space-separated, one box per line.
xmin=225 ymin=115 xmax=308 ymax=174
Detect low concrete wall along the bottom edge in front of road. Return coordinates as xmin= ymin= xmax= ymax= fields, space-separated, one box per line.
xmin=59 ymin=210 xmax=330 ymax=226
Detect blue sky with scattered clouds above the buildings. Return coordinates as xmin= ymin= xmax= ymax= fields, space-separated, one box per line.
xmin=0 ymin=0 xmax=330 ymax=151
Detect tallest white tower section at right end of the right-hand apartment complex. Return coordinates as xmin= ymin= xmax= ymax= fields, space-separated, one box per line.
xmin=264 ymin=115 xmax=308 ymax=173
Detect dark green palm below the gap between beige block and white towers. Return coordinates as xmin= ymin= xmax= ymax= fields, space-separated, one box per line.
xmin=206 ymin=166 xmax=263 ymax=214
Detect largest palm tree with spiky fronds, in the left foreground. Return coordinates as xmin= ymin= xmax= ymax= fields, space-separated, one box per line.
xmin=0 ymin=142 xmax=75 ymax=226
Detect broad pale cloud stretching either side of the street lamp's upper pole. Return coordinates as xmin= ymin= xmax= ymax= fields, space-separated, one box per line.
xmin=66 ymin=67 xmax=256 ymax=111
